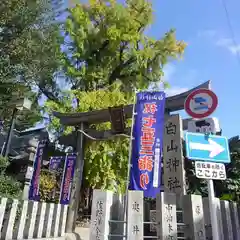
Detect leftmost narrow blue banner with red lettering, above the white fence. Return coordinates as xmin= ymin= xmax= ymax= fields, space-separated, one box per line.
xmin=28 ymin=140 xmax=46 ymax=201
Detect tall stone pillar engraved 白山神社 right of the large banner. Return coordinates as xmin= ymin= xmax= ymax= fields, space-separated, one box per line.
xmin=163 ymin=114 xmax=185 ymax=194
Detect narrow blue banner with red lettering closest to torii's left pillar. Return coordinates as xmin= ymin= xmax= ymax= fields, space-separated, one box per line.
xmin=60 ymin=153 xmax=77 ymax=204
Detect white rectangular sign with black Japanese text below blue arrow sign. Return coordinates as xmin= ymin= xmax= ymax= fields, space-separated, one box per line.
xmin=195 ymin=161 xmax=227 ymax=180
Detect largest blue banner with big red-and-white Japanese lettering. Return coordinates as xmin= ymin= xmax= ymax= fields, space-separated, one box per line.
xmin=129 ymin=92 xmax=165 ymax=198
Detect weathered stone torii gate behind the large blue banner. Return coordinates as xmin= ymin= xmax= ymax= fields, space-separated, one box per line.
xmin=53 ymin=81 xmax=210 ymax=233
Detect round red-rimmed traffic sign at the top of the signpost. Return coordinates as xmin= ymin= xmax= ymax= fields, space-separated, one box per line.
xmin=184 ymin=88 xmax=218 ymax=119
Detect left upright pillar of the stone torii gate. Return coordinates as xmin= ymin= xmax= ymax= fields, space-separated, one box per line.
xmin=66 ymin=123 xmax=84 ymax=233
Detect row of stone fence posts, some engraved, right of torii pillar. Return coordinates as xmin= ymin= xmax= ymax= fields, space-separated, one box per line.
xmin=90 ymin=190 xmax=240 ymax=240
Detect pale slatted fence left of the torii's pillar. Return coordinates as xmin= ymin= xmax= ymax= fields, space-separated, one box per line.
xmin=0 ymin=198 xmax=68 ymax=240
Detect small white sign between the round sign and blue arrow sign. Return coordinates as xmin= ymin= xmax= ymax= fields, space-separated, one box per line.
xmin=188 ymin=117 xmax=221 ymax=134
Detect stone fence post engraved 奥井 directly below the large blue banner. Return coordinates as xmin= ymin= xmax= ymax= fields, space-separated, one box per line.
xmin=127 ymin=191 xmax=144 ymax=240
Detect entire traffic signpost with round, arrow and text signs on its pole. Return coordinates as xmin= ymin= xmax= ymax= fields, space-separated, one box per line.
xmin=184 ymin=89 xmax=230 ymax=240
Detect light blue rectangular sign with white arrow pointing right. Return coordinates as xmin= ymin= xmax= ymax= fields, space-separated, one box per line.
xmin=185 ymin=132 xmax=230 ymax=163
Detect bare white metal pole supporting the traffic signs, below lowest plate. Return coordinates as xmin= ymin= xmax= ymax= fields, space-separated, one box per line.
xmin=208 ymin=179 xmax=219 ymax=240
